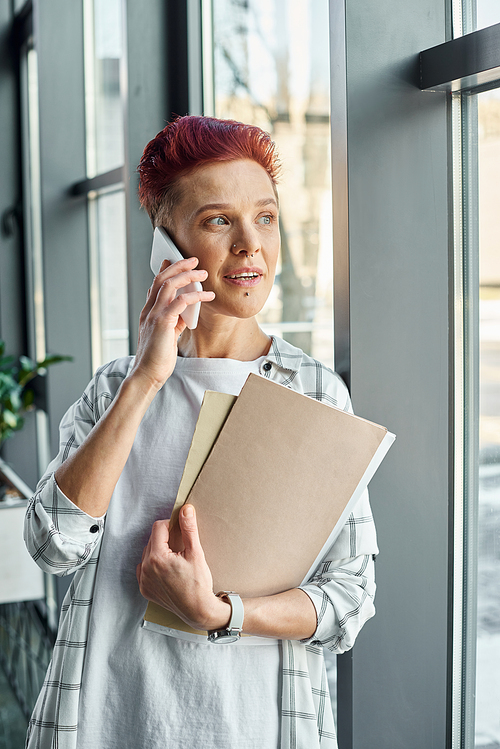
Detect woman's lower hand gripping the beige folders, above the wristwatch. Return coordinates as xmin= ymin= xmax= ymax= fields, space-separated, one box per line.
xmin=136 ymin=504 xmax=231 ymax=630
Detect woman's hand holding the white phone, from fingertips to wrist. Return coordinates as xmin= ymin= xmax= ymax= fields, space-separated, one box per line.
xmin=130 ymin=257 xmax=215 ymax=390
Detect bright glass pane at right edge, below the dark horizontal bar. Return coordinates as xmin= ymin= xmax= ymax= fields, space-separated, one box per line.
xmin=475 ymin=89 xmax=500 ymax=749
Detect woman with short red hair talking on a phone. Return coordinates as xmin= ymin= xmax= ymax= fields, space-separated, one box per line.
xmin=26 ymin=117 xmax=377 ymax=749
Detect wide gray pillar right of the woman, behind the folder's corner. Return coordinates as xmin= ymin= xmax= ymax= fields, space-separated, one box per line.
xmin=347 ymin=0 xmax=450 ymax=749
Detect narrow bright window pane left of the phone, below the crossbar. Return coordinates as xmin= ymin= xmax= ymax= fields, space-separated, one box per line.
xmin=89 ymin=190 xmax=129 ymax=369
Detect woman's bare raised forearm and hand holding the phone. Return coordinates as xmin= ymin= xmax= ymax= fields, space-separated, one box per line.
xmin=55 ymin=258 xmax=214 ymax=518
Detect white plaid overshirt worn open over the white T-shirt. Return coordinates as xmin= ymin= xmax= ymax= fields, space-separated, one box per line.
xmin=25 ymin=337 xmax=378 ymax=749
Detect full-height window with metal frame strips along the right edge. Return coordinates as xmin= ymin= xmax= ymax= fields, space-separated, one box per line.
xmin=422 ymin=0 xmax=500 ymax=749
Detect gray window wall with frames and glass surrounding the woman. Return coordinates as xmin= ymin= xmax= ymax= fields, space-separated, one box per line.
xmin=0 ymin=0 xmax=500 ymax=749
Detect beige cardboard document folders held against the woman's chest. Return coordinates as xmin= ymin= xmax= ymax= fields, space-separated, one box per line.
xmin=144 ymin=374 xmax=395 ymax=640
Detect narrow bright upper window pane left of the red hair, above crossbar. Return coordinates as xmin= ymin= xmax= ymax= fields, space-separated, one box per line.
xmin=85 ymin=0 xmax=124 ymax=177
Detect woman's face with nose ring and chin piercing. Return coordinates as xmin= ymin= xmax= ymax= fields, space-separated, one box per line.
xmin=169 ymin=159 xmax=280 ymax=318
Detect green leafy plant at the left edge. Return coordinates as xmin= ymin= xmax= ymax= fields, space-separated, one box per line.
xmin=0 ymin=340 xmax=72 ymax=445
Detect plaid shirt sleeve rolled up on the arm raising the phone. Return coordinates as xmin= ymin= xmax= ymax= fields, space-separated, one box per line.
xmin=24 ymin=362 xmax=126 ymax=576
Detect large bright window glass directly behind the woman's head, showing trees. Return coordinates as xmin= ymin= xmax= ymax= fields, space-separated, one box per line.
xmin=213 ymin=0 xmax=333 ymax=365
